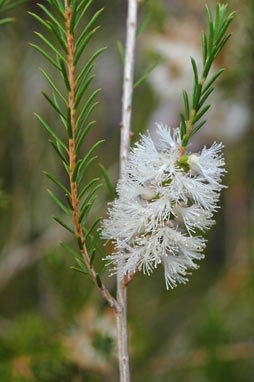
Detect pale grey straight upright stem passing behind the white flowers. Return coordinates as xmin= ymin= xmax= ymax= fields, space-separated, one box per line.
xmin=116 ymin=0 xmax=138 ymax=382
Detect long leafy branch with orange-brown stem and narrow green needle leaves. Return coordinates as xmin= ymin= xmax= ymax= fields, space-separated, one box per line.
xmin=29 ymin=0 xmax=118 ymax=308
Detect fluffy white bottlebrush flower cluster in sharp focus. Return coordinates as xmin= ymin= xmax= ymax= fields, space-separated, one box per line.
xmin=102 ymin=125 xmax=225 ymax=289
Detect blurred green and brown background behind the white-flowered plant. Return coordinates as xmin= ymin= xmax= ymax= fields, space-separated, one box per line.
xmin=0 ymin=0 xmax=254 ymax=382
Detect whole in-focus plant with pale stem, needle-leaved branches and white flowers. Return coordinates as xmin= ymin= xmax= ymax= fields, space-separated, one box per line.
xmin=31 ymin=0 xmax=234 ymax=381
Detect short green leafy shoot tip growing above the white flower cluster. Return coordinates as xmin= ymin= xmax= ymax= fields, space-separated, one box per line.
xmin=180 ymin=4 xmax=236 ymax=155
